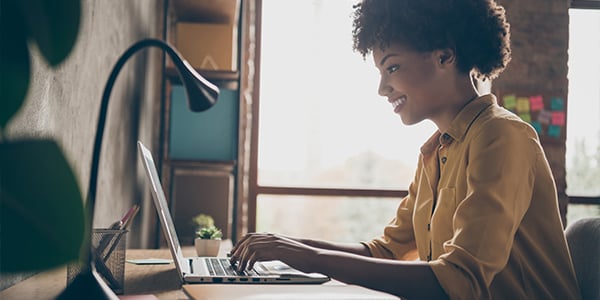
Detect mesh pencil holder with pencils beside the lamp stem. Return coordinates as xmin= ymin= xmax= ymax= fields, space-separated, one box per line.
xmin=67 ymin=229 xmax=127 ymax=294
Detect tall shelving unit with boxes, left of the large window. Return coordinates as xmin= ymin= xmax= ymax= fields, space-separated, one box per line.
xmin=162 ymin=0 xmax=241 ymax=244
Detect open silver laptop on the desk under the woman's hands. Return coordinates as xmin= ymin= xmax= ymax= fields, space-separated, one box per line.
xmin=138 ymin=141 xmax=330 ymax=284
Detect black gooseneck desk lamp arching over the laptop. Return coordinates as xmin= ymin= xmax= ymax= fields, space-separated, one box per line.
xmin=58 ymin=39 xmax=219 ymax=299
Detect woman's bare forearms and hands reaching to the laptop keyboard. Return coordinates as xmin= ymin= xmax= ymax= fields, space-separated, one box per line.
xmin=231 ymin=234 xmax=447 ymax=299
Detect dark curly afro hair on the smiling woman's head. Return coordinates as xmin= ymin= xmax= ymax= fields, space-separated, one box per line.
xmin=352 ymin=0 xmax=511 ymax=79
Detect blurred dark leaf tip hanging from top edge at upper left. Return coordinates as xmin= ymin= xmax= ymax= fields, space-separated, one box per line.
xmin=18 ymin=0 xmax=81 ymax=66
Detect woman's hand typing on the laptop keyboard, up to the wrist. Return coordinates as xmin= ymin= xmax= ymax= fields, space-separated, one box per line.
xmin=231 ymin=233 xmax=318 ymax=273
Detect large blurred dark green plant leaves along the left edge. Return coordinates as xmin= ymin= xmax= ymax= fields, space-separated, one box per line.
xmin=0 ymin=0 xmax=85 ymax=277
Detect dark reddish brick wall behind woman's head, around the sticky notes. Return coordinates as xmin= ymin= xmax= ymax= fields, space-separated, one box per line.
xmin=493 ymin=0 xmax=569 ymax=224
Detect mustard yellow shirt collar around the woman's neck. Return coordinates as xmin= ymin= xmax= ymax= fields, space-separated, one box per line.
xmin=421 ymin=94 xmax=496 ymax=154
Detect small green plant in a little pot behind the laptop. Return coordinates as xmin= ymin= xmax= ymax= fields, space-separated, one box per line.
xmin=192 ymin=214 xmax=223 ymax=256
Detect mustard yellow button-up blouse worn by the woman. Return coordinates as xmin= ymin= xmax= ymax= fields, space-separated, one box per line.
xmin=364 ymin=95 xmax=580 ymax=299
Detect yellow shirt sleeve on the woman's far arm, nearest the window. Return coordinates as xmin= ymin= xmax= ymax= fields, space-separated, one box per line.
xmin=362 ymin=157 xmax=421 ymax=259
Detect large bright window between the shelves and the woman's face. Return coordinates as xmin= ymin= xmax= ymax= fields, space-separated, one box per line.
xmin=250 ymin=0 xmax=435 ymax=241
